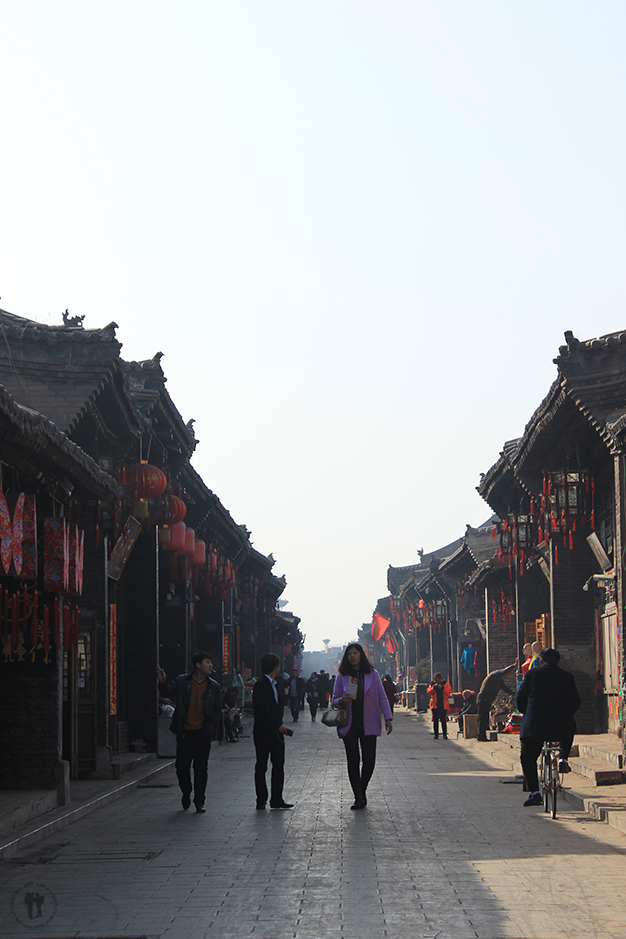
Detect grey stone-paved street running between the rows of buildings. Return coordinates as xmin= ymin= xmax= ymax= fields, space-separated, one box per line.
xmin=0 ymin=712 xmax=626 ymax=939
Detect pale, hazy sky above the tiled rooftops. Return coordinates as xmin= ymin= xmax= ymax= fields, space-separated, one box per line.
xmin=0 ymin=0 xmax=626 ymax=650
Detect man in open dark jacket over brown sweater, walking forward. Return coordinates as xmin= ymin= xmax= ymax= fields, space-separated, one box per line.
xmin=159 ymin=652 xmax=221 ymax=813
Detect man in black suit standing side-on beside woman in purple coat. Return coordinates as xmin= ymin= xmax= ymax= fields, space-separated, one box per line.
xmin=252 ymin=652 xmax=293 ymax=809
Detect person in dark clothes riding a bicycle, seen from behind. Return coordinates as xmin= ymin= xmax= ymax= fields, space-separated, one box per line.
xmin=517 ymin=649 xmax=580 ymax=805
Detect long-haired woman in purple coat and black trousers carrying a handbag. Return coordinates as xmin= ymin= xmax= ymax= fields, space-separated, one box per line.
xmin=333 ymin=642 xmax=393 ymax=809
